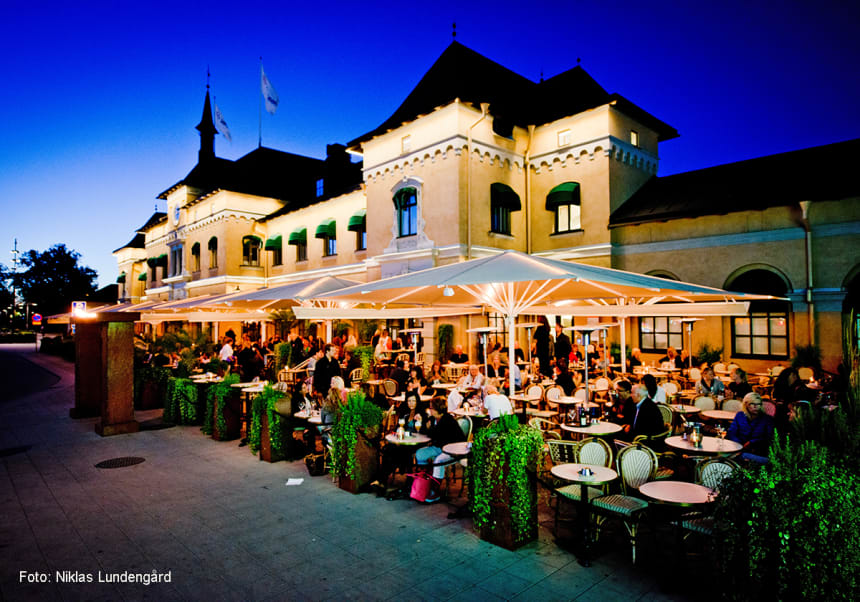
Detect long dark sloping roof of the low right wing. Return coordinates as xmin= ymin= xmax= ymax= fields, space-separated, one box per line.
xmin=609 ymin=139 xmax=860 ymax=227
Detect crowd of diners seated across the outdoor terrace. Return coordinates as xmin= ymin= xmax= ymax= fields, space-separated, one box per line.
xmin=147 ymin=319 xmax=839 ymax=486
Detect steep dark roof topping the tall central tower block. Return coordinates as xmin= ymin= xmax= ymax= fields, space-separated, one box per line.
xmin=349 ymin=42 xmax=678 ymax=147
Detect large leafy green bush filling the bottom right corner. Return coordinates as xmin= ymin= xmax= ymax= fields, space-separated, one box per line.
xmin=715 ymin=437 xmax=860 ymax=600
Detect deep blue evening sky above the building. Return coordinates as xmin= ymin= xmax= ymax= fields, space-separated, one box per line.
xmin=0 ymin=0 xmax=860 ymax=285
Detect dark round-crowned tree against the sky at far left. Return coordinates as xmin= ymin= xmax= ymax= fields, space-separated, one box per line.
xmin=13 ymin=244 xmax=98 ymax=315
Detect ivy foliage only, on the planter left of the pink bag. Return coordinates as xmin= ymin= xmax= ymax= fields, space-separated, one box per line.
xmin=331 ymin=391 xmax=382 ymax=480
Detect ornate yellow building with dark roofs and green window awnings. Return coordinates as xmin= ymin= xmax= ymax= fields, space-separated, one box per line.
xmin=116 ymin=42 xmax=860 ymax=369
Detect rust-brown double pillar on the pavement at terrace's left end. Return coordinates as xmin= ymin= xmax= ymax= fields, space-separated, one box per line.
xmin=70 ymin=312 xmax=140 ymax=437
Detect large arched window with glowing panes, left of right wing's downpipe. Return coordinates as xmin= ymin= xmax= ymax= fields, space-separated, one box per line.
xmin=725 ymin=269 xmax=790 ymax=359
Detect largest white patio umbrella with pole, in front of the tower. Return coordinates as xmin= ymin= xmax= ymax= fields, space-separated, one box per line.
xmin=314 ymin=251 xmax=763 ymax=393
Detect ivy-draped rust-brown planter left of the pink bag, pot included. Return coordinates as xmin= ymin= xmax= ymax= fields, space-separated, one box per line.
xmin=331 ymin=391 xmax=382 ymax=493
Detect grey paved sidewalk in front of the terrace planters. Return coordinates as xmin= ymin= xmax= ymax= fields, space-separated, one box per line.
xmin=0 ymin=345 xmax=700 ymax=602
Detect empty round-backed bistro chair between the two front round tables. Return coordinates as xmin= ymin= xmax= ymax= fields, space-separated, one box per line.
xmin=591 ymin=444 xmax=657 ymax=564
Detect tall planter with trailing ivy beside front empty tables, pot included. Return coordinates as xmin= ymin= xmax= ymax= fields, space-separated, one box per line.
xmin=471 ymin=416 xmax=543 ymax=550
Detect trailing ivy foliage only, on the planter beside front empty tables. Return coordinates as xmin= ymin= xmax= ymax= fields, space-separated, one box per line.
xmin=471 ymin=415 xmax=543 ymax=539
